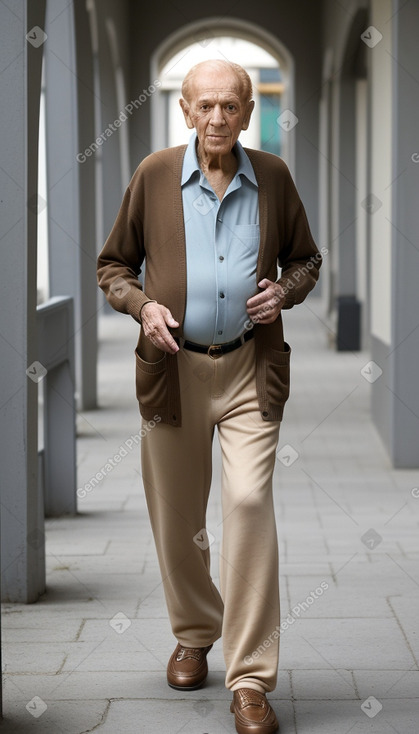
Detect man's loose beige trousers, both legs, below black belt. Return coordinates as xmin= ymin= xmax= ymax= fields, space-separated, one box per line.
xmin=141 ymin=340 xmax=280 ymax=692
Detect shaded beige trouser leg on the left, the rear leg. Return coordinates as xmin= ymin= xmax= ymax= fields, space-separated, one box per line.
xmin=141 ymin=350 xmax=223 ymax=647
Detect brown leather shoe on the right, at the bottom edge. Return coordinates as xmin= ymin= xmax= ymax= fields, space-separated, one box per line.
xmin=230 ymin=688 xmax=278 ymax=734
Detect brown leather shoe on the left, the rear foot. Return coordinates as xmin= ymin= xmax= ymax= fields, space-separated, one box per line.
xmin=167 ymin=643 xmax=212 ymax=691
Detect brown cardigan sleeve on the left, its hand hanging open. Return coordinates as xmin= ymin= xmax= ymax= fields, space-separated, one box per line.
xmin=97 ymin=179 xmax=151 ymax=322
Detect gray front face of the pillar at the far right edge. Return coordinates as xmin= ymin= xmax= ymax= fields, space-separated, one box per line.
xmin=388 ymin=0 xmax=419 ymax=467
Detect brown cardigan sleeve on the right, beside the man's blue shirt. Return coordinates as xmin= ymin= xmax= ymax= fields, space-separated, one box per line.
xmin=277 ymin=169 xmax=322 ymax=309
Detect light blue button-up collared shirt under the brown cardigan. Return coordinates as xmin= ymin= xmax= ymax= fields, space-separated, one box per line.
xmin=181 ymin=133 xmax=259 ymax=345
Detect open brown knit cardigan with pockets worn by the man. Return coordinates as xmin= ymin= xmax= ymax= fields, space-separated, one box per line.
xmin=98 ymin=145 xmax=321 ymax=426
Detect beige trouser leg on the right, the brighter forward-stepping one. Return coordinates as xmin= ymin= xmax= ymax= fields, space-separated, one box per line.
xmin=218 ymin=342 xmax=280 ymax=692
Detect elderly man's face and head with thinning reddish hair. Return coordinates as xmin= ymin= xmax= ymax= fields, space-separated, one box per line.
xmin=180 ymin=68 xmax=254 ymax=156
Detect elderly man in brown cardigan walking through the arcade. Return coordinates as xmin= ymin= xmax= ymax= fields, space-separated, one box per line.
xmin=98 ymin=61 xmax=321 ymax=734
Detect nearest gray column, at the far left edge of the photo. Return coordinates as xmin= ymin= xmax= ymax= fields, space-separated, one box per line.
xmin=0 ymin=0 xmax=45 ymax=603
